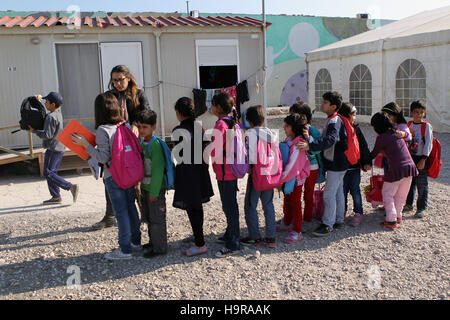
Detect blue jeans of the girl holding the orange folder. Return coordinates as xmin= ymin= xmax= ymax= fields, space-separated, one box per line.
xmin=105 ymin=177 xmax=141 ymax=253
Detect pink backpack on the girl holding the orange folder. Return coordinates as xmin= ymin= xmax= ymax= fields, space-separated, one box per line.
xmin=108 ymin=122 xmax=144 ymax=189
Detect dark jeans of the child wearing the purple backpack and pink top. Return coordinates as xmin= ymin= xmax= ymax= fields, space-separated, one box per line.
xmin=217 ymin=180 xmax=241 ymax=251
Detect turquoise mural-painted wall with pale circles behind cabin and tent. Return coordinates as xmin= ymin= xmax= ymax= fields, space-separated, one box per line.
xmin=200 ymin=13 xmax=391 ymax=106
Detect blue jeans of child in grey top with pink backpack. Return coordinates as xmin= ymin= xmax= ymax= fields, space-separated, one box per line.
xmin=244 ymin=174 xmax=276 ymax=240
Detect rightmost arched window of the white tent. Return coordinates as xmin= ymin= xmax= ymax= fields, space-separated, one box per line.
xmin=395 ymin=59 xmax=427 ymax=117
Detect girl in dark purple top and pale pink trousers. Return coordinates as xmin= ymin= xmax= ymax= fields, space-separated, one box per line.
xmin=370 ymin=112 xmax=418 ymax=228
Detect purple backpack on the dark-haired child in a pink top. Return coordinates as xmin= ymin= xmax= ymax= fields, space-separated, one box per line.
xmin=220 ymin=117 xmax=250 ymax=179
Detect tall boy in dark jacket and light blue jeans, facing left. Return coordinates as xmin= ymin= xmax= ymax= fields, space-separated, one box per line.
xmin=297 ymin=91 xmax=350 ymax=237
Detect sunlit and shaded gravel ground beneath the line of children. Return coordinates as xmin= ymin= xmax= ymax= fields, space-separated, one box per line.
xmin=0 ymin=117 xmax=450 ymax=300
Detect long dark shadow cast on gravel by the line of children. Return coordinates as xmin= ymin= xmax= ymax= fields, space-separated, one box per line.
xmin=0 ymin=211 xmax=398 ymax=295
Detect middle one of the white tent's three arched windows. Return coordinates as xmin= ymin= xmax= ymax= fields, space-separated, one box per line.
xmin=349 ymin=64 xmax=372 ymax=116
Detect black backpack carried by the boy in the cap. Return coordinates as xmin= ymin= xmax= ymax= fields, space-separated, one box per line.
xmin=19 ymin=97 xmax=47 ymax=130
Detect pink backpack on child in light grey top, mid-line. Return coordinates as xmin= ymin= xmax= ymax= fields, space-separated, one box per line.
xmin=252 ymin=138 xmax=283 ymax=191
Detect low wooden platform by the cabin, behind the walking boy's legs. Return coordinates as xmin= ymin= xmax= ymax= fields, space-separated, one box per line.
xmin=0 ymin=148 xmax=89 ymax=177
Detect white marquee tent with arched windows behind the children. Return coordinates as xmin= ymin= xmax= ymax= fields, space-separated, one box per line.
xmin=306 ymin=6 xmax=450 ymax=132
